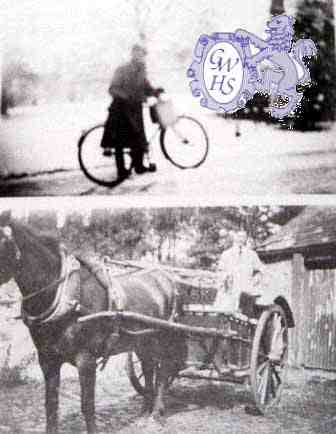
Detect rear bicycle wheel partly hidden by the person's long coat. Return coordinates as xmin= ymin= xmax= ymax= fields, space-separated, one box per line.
xmin=78 ymin=124 xmax=131 ymax=187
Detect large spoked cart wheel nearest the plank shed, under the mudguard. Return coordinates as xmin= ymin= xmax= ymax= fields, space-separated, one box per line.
xmin=250 ymin=305 xmax=288 ymax=414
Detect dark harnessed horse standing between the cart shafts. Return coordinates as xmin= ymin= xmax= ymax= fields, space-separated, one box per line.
xmin=0 ymin=212 xmax=186 ymax=434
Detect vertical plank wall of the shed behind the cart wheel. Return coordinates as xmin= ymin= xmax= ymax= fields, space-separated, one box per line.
xmin=264 ymin=254 xmax=336 ymax=370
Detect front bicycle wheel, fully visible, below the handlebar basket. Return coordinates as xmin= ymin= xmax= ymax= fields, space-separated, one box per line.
xmin=160 ymin=116 xmax=209 ymax=169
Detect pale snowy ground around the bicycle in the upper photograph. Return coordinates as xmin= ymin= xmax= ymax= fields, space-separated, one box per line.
xmin=0 ymin=95 xmax=336 ymax=196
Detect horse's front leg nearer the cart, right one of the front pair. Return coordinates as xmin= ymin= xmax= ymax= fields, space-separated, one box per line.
xmin=76 ymin=353 xmax=96 ymax=434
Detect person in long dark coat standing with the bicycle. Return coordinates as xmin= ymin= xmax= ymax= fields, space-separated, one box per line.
xmin=101 ymin=44 xmax=164 ymax=180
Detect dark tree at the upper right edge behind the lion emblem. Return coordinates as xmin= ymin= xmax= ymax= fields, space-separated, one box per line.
xmin=293 ymin=0 xmax=336 ymax=130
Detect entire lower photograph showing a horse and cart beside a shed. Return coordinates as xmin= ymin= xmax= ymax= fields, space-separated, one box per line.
xmin=0 ymin=201 xmax=336 ymax=434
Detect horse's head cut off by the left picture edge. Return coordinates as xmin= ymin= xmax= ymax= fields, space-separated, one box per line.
xmin=0 ymin=212 xmax=21 ymax=285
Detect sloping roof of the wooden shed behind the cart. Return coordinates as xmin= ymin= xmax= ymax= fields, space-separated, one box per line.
xmin=257 ymin=206 xmax=336 ymax=256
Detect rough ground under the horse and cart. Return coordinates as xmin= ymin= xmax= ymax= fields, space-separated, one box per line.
xmin=0 ymin=358 xmax=336 ymax=434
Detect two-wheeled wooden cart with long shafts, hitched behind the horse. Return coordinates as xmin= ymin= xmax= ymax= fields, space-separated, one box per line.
xmin=83 ymin=261 xmax=294 ymax=414
